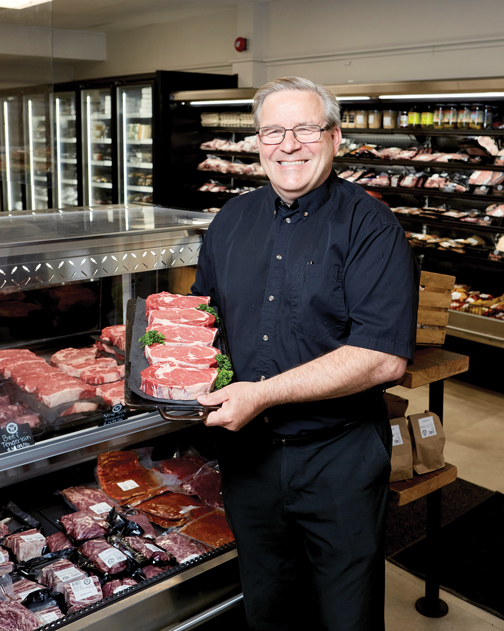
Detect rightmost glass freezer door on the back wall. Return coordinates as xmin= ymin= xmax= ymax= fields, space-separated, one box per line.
xmin=117 ymin=85 xmax=154 ymax=203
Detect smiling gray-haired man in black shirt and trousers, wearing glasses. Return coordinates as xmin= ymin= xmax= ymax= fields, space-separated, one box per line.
xmin=193 ymin=77 xmax=419 ymax=631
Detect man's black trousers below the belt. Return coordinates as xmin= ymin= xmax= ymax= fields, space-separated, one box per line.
xmin=218 ymin=415 xmax=391 ymax=631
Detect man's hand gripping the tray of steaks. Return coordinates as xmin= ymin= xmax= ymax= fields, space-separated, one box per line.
xmin=198 ymin=381 xmax=267 ymax=432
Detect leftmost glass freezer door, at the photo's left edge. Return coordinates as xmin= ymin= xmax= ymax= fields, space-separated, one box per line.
xmin=0 ymin=96 xmax=27 ymax=210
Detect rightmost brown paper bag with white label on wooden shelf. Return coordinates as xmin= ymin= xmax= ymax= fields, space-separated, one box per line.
xmin=408 ymin=411 xmax=445 ymax=475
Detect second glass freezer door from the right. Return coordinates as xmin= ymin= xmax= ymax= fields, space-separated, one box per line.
xmin=82 ymin=89 xmax=115 ymax=206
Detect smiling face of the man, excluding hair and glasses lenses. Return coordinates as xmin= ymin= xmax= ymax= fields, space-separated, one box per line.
xmin=259 ymin=90 xmax=341 ymax=204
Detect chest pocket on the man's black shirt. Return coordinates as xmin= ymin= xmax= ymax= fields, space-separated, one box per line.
xmin=291 ymin=264 xmax=348 ymax=341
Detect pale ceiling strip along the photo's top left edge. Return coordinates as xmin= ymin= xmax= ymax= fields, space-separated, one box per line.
xmin=0 ymin=0 xmax=274 ymax=33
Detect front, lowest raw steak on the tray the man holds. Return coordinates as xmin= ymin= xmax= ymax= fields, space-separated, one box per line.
xmin=140 ymin=364 xmax=218 ymax=401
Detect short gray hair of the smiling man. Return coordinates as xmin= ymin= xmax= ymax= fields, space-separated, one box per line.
xmin=252 ymin=77 xmax=340 ymax=130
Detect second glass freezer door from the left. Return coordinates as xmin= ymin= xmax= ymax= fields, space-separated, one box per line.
xmin=23 ymin=94 xmax=52 ymax=210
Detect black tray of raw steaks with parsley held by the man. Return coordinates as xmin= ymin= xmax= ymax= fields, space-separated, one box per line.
xmin=124 ymin=292 xmax=232 ymax=422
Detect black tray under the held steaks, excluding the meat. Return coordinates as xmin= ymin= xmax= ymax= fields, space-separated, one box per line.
xmin=124 ymin=298 xmax=229 ymax=422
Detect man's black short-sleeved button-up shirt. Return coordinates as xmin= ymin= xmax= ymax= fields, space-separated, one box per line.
xmin=192 ymin=172 xmax=419 ymax=435
